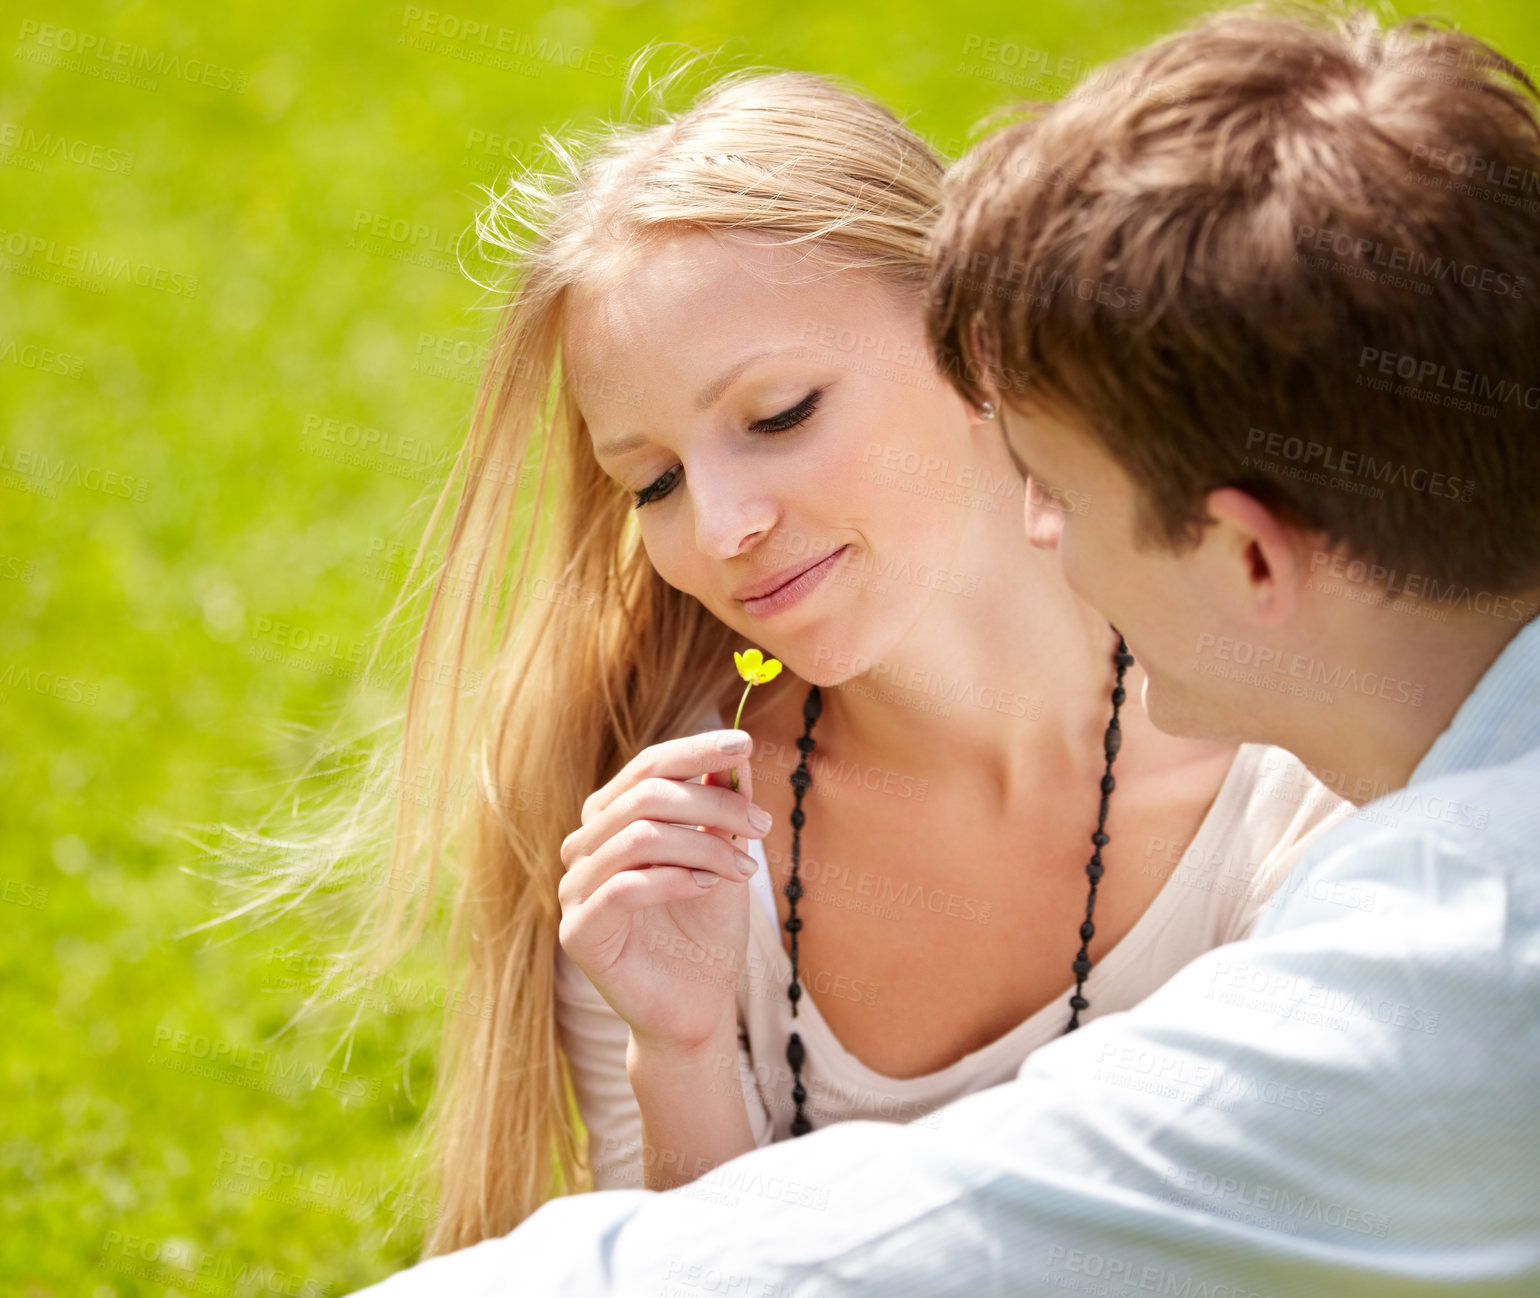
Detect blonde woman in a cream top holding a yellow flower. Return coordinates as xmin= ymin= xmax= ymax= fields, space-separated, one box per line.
xmin=354 ymin=65 xmax=1343 ymax=1252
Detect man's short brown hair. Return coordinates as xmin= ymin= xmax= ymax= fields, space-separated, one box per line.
xmin=929 ymin=9 xmax=1540 ymax=593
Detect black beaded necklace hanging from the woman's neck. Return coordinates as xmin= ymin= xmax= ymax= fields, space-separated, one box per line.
xmin=782 ymin=634 xmax=1133 ymax=1136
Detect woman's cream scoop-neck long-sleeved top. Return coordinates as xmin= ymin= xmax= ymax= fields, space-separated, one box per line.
xmin=556 ymin=711 xmax=1352 ymax=1190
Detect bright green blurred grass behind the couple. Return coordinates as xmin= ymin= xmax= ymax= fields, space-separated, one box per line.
xmin=0 ymin=0 xmax=1540 ymax=1298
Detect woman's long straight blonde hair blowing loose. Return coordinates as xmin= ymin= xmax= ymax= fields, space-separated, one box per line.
xmin=221 ymin=58 xmax=942 ymax=1255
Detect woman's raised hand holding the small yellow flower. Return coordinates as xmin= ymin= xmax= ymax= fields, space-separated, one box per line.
xmin=557 ymin=730 xmax=770 ymax=1056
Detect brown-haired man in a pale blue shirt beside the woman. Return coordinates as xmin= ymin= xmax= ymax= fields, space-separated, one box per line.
xmin=354 ymin=14 xmax=1540 ymax=1298
